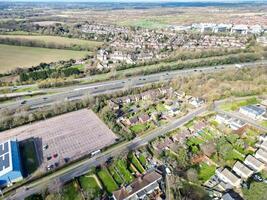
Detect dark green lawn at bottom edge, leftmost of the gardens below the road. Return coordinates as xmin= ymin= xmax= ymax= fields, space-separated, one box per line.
xmin=62 ymin=181 xmax=82 ymax=200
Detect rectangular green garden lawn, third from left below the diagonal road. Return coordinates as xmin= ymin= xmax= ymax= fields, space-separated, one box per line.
xmin=97 ymin=168 xmax=119 ymax=193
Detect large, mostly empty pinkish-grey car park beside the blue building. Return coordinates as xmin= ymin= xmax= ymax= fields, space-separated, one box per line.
xmin=0 ymin=109 xmax=117 ymax=170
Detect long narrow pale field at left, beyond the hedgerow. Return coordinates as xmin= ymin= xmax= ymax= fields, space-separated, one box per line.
xmin=0 ymin=34 xmax=102 ymax=49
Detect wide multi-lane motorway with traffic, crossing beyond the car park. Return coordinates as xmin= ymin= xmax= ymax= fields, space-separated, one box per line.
xmin=0 ymin=60 xmax=267 ymax=110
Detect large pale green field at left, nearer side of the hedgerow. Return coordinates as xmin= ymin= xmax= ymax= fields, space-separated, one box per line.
xmin=0 ymin=44 xmax=89 ymax=73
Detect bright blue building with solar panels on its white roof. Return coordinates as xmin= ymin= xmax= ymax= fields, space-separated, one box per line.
xmin=0 ymin=140 xmax=23 ymax=187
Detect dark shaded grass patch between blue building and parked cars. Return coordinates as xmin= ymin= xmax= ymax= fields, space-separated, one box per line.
xmin=19 ymin=140 xmax=39 ymax=175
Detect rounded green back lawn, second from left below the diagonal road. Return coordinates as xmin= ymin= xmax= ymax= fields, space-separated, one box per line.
xmin=79 ymin=174 xmax=101 ymax=196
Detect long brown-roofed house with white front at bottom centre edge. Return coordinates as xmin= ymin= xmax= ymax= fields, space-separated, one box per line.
xmin=113 ymin=171 xmax=162 ymax=200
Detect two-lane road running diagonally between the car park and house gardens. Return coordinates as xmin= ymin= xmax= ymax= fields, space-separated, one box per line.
xmin=5 ymin=106 xmax=206 ymax=200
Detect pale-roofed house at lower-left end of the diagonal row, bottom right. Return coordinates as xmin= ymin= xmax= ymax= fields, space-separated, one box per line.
xmin=216 ymin=168 xmax=241 ymax=187
